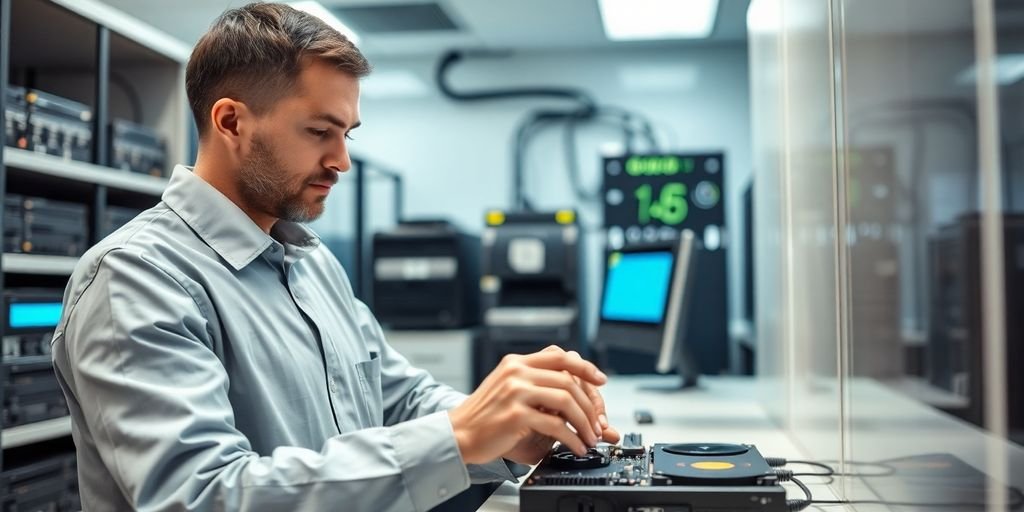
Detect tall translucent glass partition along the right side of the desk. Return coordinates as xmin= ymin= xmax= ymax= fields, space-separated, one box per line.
xmin=749 ymin=0 xmax=1024 ymax=510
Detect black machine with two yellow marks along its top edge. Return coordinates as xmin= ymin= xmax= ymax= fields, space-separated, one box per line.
xmin=480 ymin=210 xmax=581 ymax=349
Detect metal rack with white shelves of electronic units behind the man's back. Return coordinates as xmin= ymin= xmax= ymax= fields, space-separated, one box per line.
xmin=0 ymin=0 xmax=194 ymax=503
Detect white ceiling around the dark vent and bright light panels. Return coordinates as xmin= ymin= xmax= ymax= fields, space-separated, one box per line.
xmin=96 ymin=0 xmax=750 ymax=56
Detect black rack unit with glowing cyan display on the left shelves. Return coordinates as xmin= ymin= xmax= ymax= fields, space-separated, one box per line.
xmin=3 ymin=288 xmax=63 ymax=361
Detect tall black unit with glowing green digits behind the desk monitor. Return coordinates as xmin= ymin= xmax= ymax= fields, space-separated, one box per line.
xmin=602 ymin=152 xmax=730 ymax=374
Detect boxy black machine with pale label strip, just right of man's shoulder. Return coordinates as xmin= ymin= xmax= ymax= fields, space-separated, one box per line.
xmin=373 ymin=220 xmax=480 ymax=329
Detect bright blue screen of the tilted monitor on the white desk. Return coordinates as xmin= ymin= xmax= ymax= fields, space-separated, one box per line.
xmin=601 ymin=251 xmax=673 ymax=324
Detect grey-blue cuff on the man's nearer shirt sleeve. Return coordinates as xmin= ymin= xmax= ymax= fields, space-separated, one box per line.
xmin=388 ymin=411 xmax=473 ymax=511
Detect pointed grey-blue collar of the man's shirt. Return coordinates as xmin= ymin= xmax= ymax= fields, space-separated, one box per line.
xmin=162 ymin=165 xmax=319 ymax=270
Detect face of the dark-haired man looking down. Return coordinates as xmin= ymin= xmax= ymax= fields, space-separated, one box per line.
xmin=239 ymin=60 xmax=359 ymax=222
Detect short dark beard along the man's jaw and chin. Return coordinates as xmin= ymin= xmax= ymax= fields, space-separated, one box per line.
xmin=239 ymin=135 xmax=338 ymax=222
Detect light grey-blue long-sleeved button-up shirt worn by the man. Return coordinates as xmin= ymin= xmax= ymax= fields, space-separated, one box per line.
xmin=53 ymin=166 xmax=512 ymax=512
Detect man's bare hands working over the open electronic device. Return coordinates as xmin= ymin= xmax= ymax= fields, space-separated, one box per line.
xmin=449 ymin=346 xmax=618 ymax=464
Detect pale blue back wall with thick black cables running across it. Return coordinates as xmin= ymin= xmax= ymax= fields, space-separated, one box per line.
xmin=313 ymin=43 xmax=751 ymax=350
